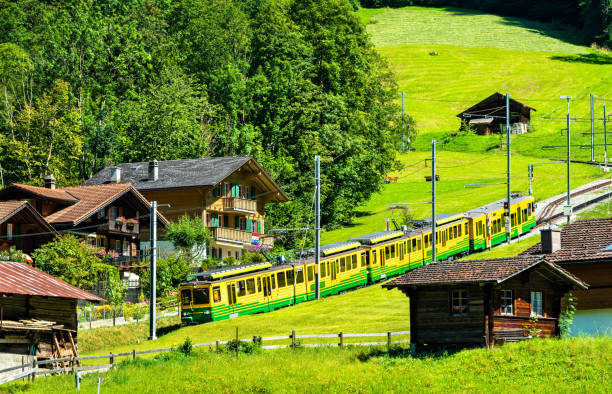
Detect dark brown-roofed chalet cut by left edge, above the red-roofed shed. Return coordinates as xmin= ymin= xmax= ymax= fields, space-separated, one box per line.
xmin=0 ymin=201 xmax=55 ymax=254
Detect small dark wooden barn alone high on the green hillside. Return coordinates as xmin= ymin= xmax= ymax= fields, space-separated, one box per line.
xmin=457 ymin=92 xmax=536 ymax=135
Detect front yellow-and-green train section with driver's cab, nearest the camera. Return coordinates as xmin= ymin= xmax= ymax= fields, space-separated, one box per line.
xmin=179 ymin=242 xmax=367 ymax=324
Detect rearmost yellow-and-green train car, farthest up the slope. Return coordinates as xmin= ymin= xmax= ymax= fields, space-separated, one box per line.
xmin=465 ymin=196 xmax=536 ymax=252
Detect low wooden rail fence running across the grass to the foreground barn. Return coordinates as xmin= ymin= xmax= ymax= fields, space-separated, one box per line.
xmin=0 ymin=329 xmax=410 ymax=384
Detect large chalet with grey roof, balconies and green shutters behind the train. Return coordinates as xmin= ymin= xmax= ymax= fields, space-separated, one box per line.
xmin=84 ymin=156 xmax=289 ymax=259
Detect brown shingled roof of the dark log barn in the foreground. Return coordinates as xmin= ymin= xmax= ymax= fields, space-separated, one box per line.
xmin=383 ymin=257 xmax=587 ymax=289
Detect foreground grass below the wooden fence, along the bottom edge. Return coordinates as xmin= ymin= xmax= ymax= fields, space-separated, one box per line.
xmin=5 ymin=337 xmax=612 ymax=393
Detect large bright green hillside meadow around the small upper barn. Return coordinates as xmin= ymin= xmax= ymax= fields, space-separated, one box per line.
xmin=322 ymin=7 xmax=612 ymax=243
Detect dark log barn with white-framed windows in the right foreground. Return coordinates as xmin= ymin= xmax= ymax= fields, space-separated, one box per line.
xmin=383 ymin=258 xmax=587 ymax=351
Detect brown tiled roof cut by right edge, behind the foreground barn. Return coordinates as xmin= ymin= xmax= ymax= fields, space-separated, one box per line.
xmin=519 ymin=218 xmax=612 ymax=264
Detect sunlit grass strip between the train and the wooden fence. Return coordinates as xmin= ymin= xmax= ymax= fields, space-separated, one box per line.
xmin=79 ymin=285 xmax=410 ymax=353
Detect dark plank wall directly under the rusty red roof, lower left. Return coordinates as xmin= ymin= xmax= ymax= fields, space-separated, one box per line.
xmin=0 ymin=294 xmax=78 ymax=330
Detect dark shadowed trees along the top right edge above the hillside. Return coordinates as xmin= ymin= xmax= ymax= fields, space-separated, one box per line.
xmin=359 ymin=0 xmax=612 ymax=47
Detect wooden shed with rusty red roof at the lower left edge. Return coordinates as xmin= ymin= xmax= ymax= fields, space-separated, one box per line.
xmin=0 ymin=261 xmax=104 ymax=367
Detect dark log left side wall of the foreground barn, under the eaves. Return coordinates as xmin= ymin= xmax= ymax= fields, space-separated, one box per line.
xmin=409 ymin=285 xmax=485 ymax=346
